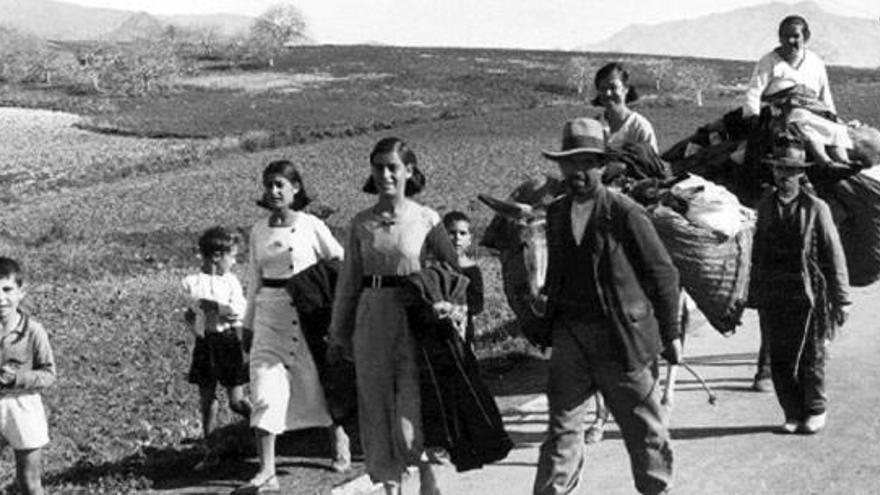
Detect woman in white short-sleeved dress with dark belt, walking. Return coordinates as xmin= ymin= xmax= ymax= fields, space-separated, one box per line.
xmin=244 ymin=160 xmax=351 ymax=493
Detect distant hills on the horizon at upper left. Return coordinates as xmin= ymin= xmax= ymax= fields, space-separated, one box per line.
xmin=0 ymin=0 xmax=252 ymax=40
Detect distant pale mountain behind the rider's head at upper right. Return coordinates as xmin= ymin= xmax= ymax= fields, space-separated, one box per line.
xmin=579 ymin=2 xmax=880 ymax=67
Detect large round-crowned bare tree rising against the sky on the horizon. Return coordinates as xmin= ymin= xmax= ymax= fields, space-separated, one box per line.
xmin=250 ymin=3 xmax=307 ymax=67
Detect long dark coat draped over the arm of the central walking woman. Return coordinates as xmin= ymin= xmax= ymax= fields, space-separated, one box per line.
xmin=404 ymin=265 xmax=513 ymax=471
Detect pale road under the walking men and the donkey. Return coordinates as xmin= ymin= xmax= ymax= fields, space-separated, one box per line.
xmin=406 ymin=287 xmax=880 ymax=495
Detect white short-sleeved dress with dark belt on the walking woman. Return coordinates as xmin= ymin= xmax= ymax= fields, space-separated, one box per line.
xmin=244 ymin=212 xmax=343 ymax=434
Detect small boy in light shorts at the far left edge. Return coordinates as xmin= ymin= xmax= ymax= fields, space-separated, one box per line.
xmin=0 ymin=257 xmax=55 ymax=495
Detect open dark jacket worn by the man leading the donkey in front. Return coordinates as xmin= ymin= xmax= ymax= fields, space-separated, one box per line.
xmin=545 ymin=187 xmax=681 ymax=370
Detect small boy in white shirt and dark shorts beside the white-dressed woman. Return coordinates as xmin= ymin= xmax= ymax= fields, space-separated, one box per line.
xmin=183 ymin=227 xmax=251 ymax=471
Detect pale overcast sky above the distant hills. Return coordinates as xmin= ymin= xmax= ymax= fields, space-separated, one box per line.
xmin=66 ymin=0 xmax=880 ymax=49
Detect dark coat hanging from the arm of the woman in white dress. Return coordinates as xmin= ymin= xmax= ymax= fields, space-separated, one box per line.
xmin=286 ymin=259 xmax=357 ymax=422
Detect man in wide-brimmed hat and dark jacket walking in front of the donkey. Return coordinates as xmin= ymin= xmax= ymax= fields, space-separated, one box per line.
xmin=534 ymin=118 xmax=681 ymax=495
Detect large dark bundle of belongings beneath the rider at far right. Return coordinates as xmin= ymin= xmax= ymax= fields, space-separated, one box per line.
xmin=663 ymin=86 xmax=880 ymax=287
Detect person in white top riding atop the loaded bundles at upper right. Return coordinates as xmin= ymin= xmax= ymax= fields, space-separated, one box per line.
xmin=743 ymin=15 xmax=853 ymax=165
